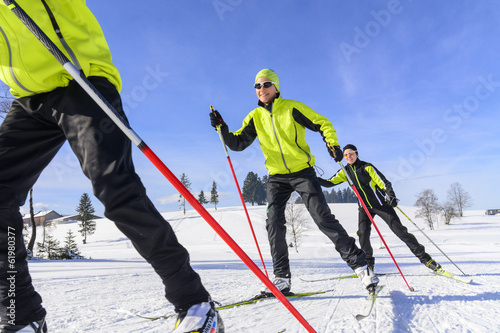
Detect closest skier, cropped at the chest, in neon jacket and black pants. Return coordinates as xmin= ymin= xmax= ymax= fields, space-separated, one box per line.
xmin=0 ymin=0 xmax=224 ymax=332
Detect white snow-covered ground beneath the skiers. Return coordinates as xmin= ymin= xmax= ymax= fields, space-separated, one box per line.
xmin=29 ymin=204 xmax=500 ymax=333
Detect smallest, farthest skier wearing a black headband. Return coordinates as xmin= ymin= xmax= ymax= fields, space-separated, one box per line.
xmin=320 ymin=144 xmax=441 ymax=271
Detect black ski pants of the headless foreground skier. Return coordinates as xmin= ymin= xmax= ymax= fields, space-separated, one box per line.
xmin=0 ymin=77 xmax=209 ymax=324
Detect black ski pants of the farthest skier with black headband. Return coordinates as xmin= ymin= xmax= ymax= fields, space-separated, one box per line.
xmin=358 ymin=205 xmax=431 ymax=264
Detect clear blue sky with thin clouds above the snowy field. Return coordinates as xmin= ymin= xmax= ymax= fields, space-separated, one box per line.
xmin=8 ymin=0 xmax=500 ymax=214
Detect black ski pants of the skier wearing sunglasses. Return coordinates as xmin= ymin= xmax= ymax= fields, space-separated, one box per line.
xmin=266 ymin=167 xmax=366 ymax=277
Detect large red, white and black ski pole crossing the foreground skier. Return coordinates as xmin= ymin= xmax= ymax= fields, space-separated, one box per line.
xmin=4 ymin=0 xmax=316 ymax=332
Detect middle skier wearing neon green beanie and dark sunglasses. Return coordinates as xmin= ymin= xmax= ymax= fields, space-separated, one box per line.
xmin=210 ymin=69 xmax=378 ymax=293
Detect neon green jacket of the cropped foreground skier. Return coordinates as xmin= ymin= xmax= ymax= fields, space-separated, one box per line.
xmin=0 ymin=0 xmax=122 ymax=97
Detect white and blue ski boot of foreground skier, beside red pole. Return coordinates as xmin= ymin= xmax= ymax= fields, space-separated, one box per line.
xmin=172 ymin=302 xmax=224 ymax=333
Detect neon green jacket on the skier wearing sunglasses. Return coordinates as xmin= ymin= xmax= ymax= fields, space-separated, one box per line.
xmin=221 ymin=97 xmax=338 ymax=175
